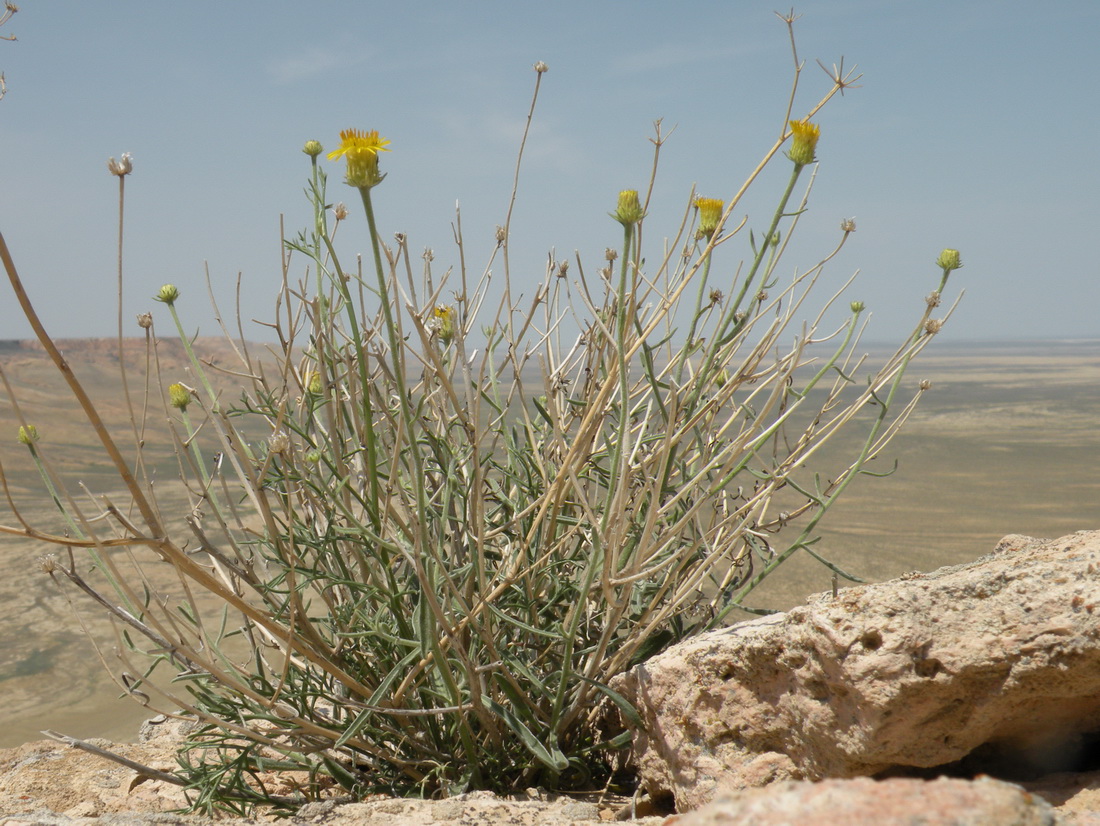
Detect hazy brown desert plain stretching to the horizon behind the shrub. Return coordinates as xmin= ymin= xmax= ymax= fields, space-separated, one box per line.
xmin=0 ymin=340 xmax=1100 ymax=747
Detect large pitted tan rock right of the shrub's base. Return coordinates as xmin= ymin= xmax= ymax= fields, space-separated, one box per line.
xmin=613 ymin=531 xmax=1100 ymax=812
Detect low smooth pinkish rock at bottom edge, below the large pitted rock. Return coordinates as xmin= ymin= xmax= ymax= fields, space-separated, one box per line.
xmin=666 ymin=778 xmax=1066 ymax=826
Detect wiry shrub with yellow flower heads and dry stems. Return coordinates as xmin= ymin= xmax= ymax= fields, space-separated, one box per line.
xmin=2 ymin=12 xmax=960 ymax=808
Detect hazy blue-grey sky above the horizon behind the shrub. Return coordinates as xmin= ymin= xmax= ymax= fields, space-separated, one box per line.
xmin=0 ymin=0 xmax=1100 ymax=343
